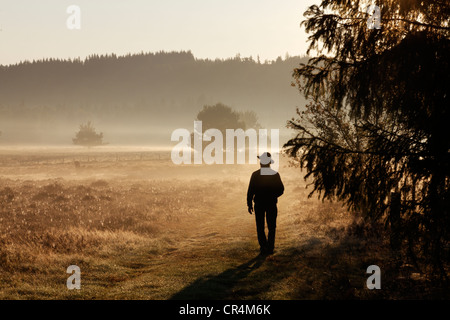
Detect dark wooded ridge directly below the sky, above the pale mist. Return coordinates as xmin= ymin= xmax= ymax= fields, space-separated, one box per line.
xmin=0 ymin=52 xmax=302 ymax=107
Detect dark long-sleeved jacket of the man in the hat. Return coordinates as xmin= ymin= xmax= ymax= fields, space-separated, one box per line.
xmin=247 ymin=169 xmax=284 ymax=207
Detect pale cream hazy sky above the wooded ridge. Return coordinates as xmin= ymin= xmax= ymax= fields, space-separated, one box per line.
xmin=0 ymin=0 xmax=318 ymax=65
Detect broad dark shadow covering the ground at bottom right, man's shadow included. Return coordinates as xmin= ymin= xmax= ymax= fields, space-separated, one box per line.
xmin=170 ymin=232 xmax=450 ymax=300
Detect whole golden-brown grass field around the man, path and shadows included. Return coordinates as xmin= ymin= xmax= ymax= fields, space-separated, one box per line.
xmin=0 ymin=148 xmax=448 ymax=300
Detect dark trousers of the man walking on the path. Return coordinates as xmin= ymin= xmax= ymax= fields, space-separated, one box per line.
xmin=255 ymin=203 xmax=278 ymax=251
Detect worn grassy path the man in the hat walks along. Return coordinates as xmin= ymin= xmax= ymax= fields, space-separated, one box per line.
xmin=100 ymin=171 xmax=322 ymax=299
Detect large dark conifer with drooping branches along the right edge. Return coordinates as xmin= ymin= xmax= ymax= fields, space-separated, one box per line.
xmin=285 ymin=0 xmax=450 ymax=277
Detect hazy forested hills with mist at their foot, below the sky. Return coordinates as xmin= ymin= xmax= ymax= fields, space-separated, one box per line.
xmin=0 ymin=52 xmax=306 ymax=143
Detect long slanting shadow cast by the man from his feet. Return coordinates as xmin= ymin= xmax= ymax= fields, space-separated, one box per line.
xmin=170 ymin=255 xmax=266 ymax=300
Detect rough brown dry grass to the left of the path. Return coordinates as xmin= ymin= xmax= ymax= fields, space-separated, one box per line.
xmin=0 ymin=171 xmax=218 ymax=298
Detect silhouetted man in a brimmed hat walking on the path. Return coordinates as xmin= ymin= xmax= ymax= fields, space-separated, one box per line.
xmin=247 ymin=152 xmax=284 ymax=254
